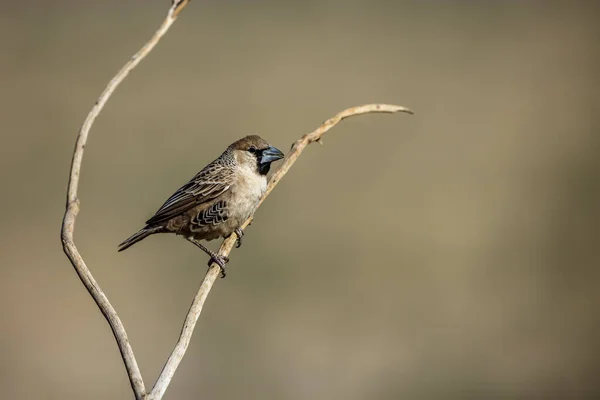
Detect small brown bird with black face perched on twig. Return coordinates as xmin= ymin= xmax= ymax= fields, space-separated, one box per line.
xmin=118 ymin=135 xmax=284 ymax=278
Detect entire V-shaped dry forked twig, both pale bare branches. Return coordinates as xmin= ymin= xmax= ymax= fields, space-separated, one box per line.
xmin=61 ymin=0 xmax=412 ymax=400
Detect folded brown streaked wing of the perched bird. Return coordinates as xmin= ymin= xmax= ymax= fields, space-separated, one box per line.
xmin=146 ymin=162 xmax=233 ymax=225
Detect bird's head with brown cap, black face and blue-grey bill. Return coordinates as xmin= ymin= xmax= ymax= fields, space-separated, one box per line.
xmin=229 ymin=135 xmax=284 ymax=175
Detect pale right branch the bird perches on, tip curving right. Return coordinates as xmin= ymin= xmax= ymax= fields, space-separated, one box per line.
xmin=150 ymin=104 xmax=413 ymax=399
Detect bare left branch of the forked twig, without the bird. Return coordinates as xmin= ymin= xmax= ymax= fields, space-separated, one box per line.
xmin=61 ymin=0 xmax=189 ymax=400
